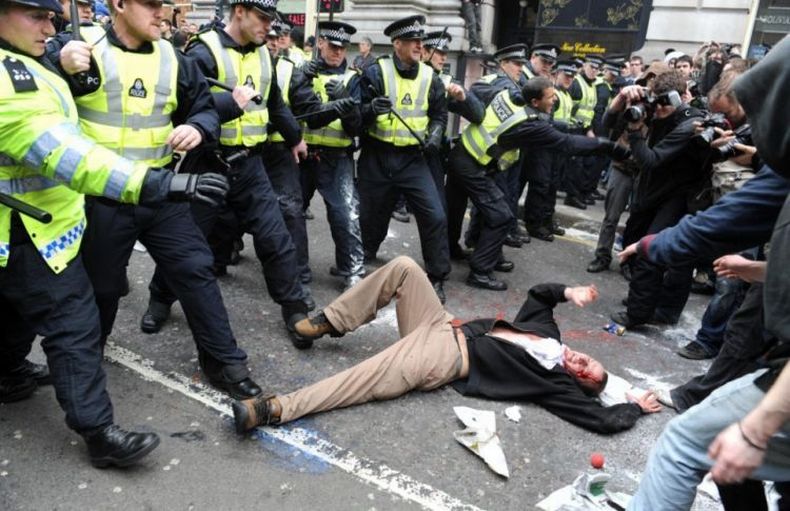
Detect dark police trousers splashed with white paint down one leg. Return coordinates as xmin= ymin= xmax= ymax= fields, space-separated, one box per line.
xmin=301 ymin=146 xmax=365 ymax=276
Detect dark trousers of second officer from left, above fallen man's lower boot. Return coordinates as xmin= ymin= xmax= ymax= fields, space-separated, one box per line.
xmin=82 ymin=198 xmax=247 ymax=371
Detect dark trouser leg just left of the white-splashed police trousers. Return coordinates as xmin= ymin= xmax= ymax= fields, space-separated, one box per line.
xmin=263 ymin=142 xmax=314 ymax=282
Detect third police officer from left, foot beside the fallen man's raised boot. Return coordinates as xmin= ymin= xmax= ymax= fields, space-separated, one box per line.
xmin=151 ymin=0 xmax=315 ymax=349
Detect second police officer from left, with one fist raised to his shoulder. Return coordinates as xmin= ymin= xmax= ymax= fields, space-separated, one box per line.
xmin=53 ymin=0 xmax=261 ymax=396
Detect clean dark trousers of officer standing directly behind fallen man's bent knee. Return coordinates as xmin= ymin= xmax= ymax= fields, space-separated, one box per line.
xmin=358 ymin=141 xmax=450 ymax=281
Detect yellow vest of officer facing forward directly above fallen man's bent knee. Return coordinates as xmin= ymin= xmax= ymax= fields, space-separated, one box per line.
xmin=368 ymin=57 xmax=433 ymax=147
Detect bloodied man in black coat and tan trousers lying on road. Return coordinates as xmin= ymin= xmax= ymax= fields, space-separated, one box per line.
xmin=233 ymin=256 xmax=661 ymax=433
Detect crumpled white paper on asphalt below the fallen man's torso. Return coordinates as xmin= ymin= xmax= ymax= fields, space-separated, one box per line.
xmin=453 ymin=406 xmax=510 ymax=477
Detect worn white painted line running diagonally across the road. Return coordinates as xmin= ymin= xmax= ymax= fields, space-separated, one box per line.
xmin=104 ymin=342 xmax=480 ymax=511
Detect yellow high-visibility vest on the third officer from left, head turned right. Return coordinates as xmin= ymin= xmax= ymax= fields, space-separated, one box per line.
xmin=198 ymin=30 xmax=272 ymax=147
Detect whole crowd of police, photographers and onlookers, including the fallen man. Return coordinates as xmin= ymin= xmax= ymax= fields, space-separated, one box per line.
xmin=0 ymin=0 xmax=790 ymax=510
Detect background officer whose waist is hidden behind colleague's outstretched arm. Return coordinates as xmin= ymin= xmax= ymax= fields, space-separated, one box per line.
xmin=565 ymin=56 xmax=603 ymax=209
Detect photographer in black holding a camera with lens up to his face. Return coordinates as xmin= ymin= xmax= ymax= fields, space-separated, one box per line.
xmin=611 ymin=70 xmax=707 ymax=328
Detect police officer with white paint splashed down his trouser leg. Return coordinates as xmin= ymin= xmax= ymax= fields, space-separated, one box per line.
xmin=301 ymin=21 xmax=365 ymax=289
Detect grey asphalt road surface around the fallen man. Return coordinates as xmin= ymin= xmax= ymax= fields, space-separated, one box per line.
xmin=0 ymin=199 xmax=732 ymax=510
